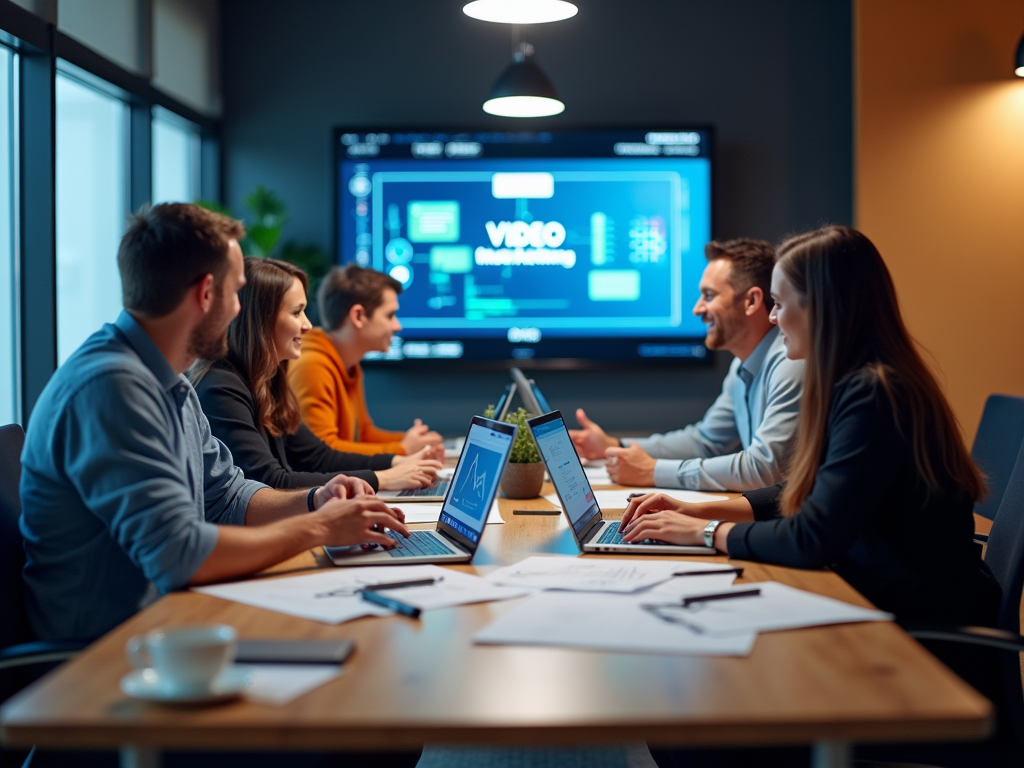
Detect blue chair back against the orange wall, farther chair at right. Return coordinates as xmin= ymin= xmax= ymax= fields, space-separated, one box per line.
xmin=971 ymin=394 xmax=1024 ymax=520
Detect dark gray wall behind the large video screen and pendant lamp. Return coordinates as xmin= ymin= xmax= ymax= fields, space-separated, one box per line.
xmin=221 ymin=0 xmax=853 ymax=433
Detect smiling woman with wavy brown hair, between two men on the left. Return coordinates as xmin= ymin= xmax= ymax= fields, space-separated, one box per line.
xmin=189 ymin=257 xmax=441 ymax=490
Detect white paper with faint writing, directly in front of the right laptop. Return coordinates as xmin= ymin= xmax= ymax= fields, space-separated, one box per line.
xmin=487 ymin=557 xmax=680 ymax=593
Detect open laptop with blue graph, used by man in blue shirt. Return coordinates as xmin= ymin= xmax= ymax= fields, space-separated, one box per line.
xmin=324 ymin=416 xmax=517 ymax=565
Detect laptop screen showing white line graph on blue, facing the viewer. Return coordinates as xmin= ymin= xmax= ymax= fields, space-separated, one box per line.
xmin=440 ymin=424 xmax=512 ymax=544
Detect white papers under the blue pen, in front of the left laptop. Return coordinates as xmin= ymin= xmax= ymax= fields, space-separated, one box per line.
xmin=194 ymin=565 xmax=525 ymax=624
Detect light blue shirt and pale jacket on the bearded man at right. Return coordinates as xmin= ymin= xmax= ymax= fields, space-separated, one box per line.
xmin=623 ymin=328 xmax=804 ymax=490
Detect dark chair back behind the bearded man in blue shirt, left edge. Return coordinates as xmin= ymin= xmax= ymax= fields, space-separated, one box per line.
xmin=0 ymin=424 xmax=32 ymax=647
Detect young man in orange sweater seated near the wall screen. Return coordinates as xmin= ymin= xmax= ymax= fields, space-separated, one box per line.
xmin=288 ymin=264 xmax=444 ymax=458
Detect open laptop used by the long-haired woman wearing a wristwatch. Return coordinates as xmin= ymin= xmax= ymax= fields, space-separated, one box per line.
xmin=526 ymin=411 xmax=715 ymax=555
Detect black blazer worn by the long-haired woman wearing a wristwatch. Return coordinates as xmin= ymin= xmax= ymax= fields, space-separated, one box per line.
xmin=728 ymin=369 xmax=1000 ymax=627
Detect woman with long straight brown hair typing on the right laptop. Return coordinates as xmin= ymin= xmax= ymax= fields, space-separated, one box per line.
xmin=623 ymin=226 xmax=999 ymax=626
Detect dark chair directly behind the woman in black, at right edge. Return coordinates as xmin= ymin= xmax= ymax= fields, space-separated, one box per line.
xmin=985 ymin=438 xmax=1024 ymax=743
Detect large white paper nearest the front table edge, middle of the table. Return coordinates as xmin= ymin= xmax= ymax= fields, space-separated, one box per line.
xmin=473 ymin=592 xmax=757 ymax=656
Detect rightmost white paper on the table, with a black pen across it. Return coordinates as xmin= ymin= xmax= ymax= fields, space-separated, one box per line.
xmin=662 ymin=580 xmax=893 ymax=637
